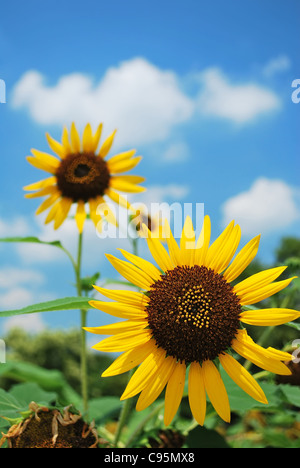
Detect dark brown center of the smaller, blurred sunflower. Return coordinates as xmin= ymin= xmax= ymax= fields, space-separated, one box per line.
xmin=56 ymin=153 xmax=110 ymax=202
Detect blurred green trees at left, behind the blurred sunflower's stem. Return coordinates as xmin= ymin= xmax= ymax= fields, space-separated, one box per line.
xmin=0 ymin=328 xmax=126 ymax=398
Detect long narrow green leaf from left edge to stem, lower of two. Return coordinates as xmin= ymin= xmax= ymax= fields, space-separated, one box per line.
xmin=0 ymin=297 xmax=91 ymax=317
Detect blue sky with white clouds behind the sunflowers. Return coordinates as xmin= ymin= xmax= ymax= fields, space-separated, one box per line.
xmin=0 ymin=0 xmax=300 ymax=333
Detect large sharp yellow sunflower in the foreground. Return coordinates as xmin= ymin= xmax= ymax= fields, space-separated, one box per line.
xmin=86 ymin=216 xmax=300 ymax=425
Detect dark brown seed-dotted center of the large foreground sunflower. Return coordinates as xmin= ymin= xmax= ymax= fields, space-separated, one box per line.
xmin=147 ymin=265 xmax=241 ymax=363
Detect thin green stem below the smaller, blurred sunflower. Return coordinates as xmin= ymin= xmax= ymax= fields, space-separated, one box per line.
xmin=75 ymin=233 xmax=88 ymax=413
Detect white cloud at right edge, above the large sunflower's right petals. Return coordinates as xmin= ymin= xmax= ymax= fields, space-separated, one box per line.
xmin=222 ymin=178 xmax=300 ymax=235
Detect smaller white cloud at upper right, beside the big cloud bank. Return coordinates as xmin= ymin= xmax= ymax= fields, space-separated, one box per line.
xmin=198 ymin=68 xmax=280 ymax=124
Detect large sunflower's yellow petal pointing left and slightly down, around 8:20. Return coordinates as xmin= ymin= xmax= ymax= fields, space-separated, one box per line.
xmin=92 ymin=330 xmax=151 ymax=353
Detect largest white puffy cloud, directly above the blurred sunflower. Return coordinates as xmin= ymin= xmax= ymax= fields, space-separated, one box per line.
xmin=13 ymin=58 xmax=194 ymax=145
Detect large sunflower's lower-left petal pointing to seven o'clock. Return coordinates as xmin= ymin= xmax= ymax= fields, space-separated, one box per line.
xmin=136 ymin=356 xmax=176 ymax=411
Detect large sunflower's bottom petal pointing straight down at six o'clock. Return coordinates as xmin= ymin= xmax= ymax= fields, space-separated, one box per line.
xmin=189 ymin=362 xmax=206 ymax=426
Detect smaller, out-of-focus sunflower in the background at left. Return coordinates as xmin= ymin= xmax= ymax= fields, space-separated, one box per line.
xmin=24 ymin=123 xmax=145 ymax=232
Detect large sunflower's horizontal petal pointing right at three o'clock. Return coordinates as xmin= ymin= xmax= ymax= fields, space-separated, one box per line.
xmin=240 ymin=308 xmax=300 ymax=327
